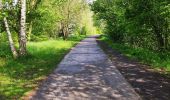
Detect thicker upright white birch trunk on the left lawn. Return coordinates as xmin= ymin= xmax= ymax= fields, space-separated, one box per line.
xmin=19 ymin=0 xmax=27 ymax=56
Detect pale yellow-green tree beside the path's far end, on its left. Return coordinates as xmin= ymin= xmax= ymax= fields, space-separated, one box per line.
xmin=59 ymin=0 xmax=87 ymax=39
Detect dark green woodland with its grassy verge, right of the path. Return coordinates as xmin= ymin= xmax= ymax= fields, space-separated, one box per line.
xmin=91 ymin=0 xmax=170 ymax=69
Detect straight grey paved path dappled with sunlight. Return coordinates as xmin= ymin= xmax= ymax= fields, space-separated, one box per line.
xmin=31 ymin=37 xmax=140 ymax=100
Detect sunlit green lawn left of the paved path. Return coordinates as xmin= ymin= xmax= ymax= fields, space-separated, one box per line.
xmin=0 ymin=37 xmax=82 ymax=100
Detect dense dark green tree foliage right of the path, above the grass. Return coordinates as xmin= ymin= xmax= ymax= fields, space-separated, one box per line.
xmin=92 ymin=0 xmax=170 ymax=51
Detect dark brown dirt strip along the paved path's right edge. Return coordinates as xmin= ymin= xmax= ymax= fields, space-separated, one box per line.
xmin=98 ymin=39 xmax=170 ymax=100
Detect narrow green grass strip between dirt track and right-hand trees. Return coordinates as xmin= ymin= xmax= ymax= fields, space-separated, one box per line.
xmin=101 ymin=36 xmax=170 ymax=72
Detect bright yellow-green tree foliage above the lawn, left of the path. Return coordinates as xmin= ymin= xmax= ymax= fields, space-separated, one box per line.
xmin=0 ymin=0 xmax=95 ymax=41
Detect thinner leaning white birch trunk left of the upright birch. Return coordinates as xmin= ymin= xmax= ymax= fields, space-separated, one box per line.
xmin=4 ymin=17 xmax=18 ymax=59
